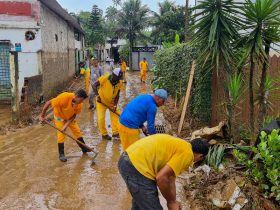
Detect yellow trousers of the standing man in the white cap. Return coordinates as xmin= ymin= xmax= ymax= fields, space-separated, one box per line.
xmin=96 ymin=101 xmax=120 ymax=136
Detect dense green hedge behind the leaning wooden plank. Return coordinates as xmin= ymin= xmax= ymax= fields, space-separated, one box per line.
xmin=153 ymin=43 xmax=211 ymax=122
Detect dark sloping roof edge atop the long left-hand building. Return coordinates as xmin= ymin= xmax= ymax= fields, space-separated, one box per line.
xmin=39 ymin=0 xmax=85 ymax=34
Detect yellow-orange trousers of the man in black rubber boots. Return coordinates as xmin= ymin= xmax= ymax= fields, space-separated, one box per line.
xmin=54 ymin=120 xmax=83 ymax=143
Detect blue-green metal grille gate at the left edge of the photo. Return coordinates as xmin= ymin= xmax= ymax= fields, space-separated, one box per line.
xmin=0 ymin=42 xmax=11 ymax=102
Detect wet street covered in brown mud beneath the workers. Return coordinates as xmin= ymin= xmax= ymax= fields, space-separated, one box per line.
xmin=0 ymin=73 xmax=188 ymax=210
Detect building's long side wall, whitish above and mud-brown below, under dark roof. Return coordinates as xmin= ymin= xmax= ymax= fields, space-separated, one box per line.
xmin=41 ymin=5 xmax=75 ymax=97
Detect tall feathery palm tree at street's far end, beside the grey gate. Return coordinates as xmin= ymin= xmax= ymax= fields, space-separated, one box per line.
xmin=117 ymin=0 xmax=149 ymax=70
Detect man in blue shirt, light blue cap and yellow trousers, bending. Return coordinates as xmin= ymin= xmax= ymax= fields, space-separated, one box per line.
xmin=118 ymin=89 xmax=167 ymax=150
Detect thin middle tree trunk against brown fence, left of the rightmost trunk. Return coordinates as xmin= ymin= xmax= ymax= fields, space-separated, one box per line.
xmin=249 ymin=53 xmax=255 ymax=141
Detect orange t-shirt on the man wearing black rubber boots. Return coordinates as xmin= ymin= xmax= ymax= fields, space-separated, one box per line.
xmin=51 ymin=92 xmax=83 ymax=120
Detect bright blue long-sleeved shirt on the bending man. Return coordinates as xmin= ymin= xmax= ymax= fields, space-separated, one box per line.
xmin=120 ymin=95 xmax=157 ymax=134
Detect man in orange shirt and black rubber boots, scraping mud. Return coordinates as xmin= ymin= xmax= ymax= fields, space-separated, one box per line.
xmin=40 ymin=89 xmax=90 ymax=162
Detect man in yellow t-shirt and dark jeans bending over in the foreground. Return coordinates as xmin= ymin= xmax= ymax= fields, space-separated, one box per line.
xmin=118 ymin=134 xmax=209 ymax=210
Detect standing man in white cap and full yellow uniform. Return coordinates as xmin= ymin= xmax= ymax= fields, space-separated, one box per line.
xmin=93 ymin=68 xmax=122 ymax=140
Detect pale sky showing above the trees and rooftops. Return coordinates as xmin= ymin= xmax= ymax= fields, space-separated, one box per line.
xmin=57 ymin=0 xmax=195 ymax=13
